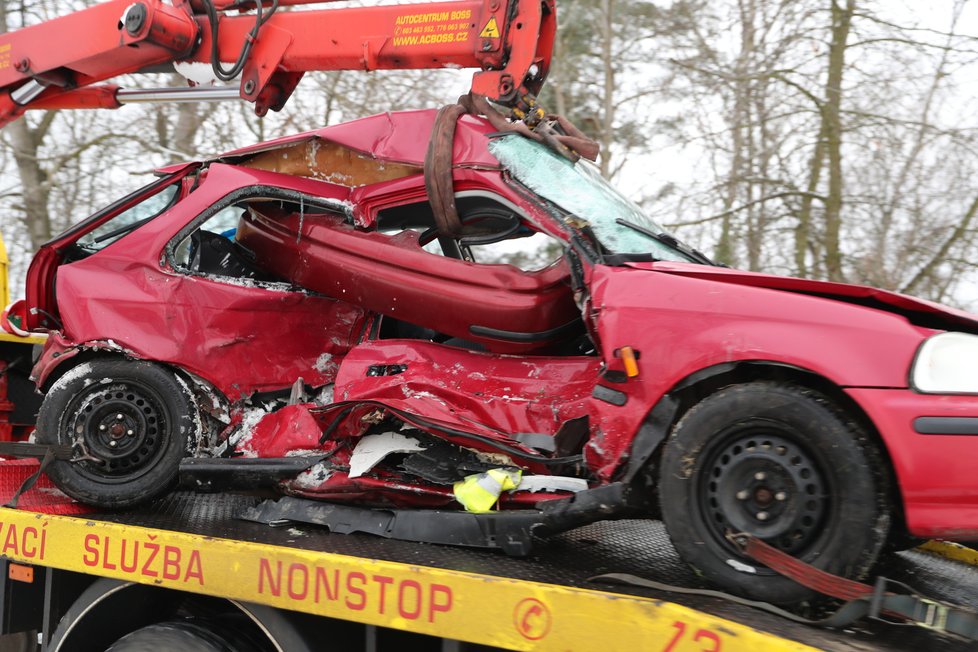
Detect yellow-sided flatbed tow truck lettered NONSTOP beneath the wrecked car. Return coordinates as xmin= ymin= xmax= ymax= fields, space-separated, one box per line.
xmin=0 ymin=476 xmax=978 ymax=652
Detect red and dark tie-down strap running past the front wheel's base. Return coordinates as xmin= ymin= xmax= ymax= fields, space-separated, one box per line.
xmin=589 ymin=534 xmax=978 ymax=641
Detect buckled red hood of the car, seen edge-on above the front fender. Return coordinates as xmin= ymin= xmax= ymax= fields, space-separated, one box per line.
xmin=628 ymin=262 xmax=978 ymax=333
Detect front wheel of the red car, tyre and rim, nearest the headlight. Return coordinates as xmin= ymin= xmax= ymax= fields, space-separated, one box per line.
xmin=659 ymin=382 xmax=890 ymax=605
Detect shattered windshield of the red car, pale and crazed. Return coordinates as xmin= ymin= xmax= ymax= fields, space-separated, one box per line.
xmin=489 ymin=134 xmax=702 ymax=262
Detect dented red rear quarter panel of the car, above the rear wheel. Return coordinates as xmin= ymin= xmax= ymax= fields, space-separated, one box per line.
xmin=49 ymin=165 xmax=365 ymax=401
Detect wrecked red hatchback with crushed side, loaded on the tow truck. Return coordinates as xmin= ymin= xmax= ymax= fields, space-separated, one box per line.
xmin=9 ymin=111 xmax=978 ymax=603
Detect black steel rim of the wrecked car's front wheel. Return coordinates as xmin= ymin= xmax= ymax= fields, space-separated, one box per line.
xmin=697 ymin=420 xmax=836 ymax=558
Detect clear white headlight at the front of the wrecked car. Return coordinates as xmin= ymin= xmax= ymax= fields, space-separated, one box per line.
xmin=910 ymin=333 xmax=978 ymax=394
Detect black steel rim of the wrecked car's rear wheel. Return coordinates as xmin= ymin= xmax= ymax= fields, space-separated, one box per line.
xmin=64 ymin=380 xmax=172 ymax=483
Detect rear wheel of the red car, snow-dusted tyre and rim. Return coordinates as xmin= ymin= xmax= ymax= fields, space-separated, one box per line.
xmin=37 ymin=360 xmax=200 ymax=508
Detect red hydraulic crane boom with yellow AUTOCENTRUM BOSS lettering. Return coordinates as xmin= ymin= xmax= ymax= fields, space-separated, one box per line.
xmin=0 ymin=0 xmax=556 ymax=127
